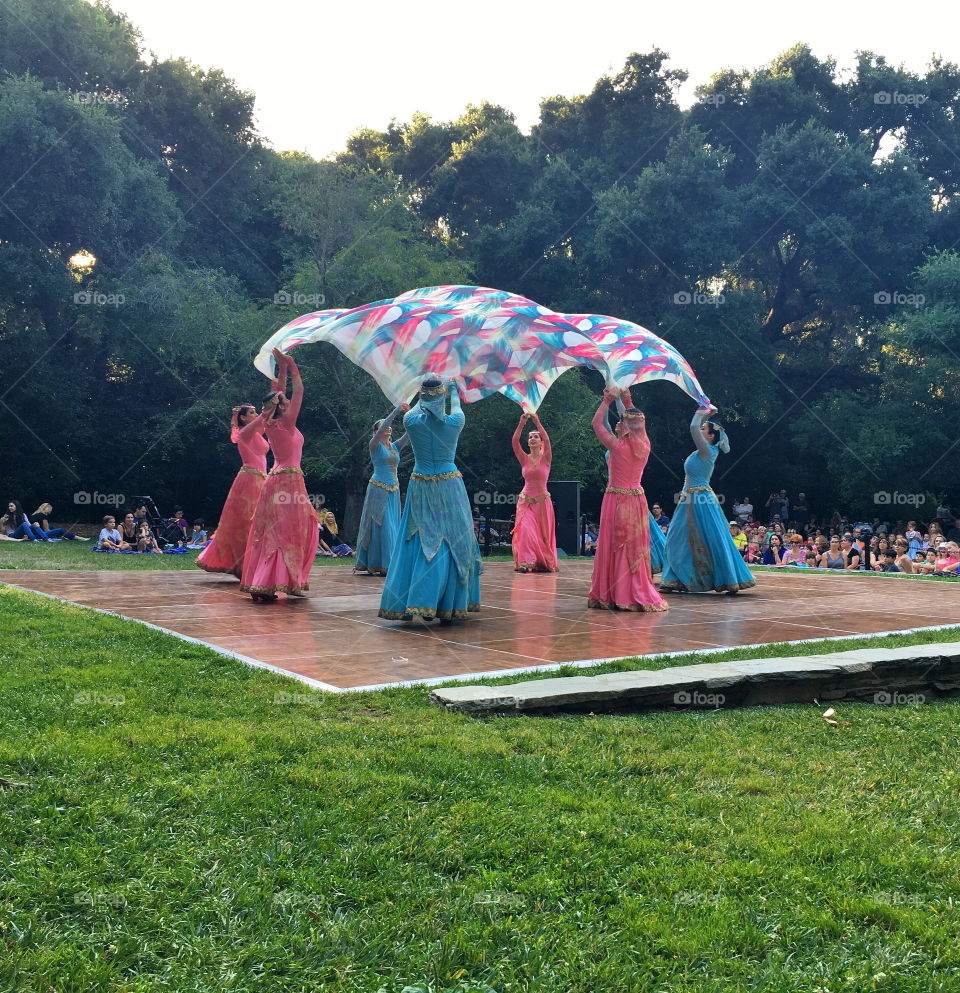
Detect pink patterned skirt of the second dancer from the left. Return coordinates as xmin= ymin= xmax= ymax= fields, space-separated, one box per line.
xmin=240 ymin=469 xmax=317 ymax=593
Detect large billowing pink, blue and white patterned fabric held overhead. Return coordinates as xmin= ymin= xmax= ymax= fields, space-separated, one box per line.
xmin=254 ymin=285 xmax=707 ymax=412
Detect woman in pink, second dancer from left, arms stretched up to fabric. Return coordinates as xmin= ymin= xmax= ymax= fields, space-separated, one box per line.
xmin=240 ymin=349 xmax=317 ymax=601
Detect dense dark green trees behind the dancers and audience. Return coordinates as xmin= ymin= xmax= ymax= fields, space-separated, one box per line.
xmin=0 ymin=0 xmax=960 ymax=531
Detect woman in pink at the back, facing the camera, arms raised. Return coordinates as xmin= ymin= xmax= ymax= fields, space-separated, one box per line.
xmin=513 ymin=414 xmax=558 ymax=572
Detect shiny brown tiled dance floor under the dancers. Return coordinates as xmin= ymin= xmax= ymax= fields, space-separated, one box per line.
xmin=2 ymin=561 xmax=960 ymax=690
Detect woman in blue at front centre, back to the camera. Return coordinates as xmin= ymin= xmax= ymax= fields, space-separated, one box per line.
xmin=380 ymin=377 xmax=483 ymax=623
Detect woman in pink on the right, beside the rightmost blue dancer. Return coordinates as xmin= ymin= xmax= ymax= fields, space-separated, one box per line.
xmin=587 ymin=390 xmax=667 ymax=611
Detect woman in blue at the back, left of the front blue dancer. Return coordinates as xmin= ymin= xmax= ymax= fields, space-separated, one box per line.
xmin=353 ymin=403 xmax=410 ymax=576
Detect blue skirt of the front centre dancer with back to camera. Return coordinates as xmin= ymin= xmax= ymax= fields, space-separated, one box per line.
xmin=379 ymin=474 xmax=483 ymax=620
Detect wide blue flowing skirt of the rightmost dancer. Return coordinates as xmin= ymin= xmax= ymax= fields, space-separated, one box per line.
xmin=660 ymin=487 xmax=756 ymax=593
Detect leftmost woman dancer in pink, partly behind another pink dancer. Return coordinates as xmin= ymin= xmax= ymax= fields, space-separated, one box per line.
xmin=197 ymin=403 xmax=270 ymax=579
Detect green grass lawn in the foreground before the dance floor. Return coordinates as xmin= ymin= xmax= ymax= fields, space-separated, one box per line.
xmin=0 ymin=580 xmax=960 ymax=993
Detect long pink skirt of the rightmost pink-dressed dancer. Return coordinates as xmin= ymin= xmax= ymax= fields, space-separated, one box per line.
xmin=587 ymin=490 xmax=667 ymax=611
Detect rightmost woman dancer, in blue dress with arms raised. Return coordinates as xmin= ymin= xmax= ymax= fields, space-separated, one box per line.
xmin=660 ymin=407 xmax=756 ymax=593
